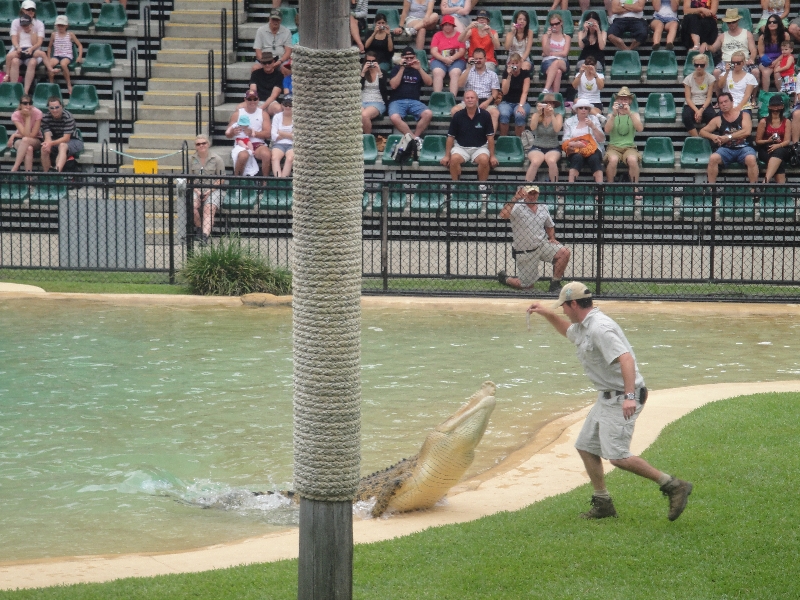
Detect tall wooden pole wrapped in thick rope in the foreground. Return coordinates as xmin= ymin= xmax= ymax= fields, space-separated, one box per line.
xmin=292 ymin=0 xmax=364 ymax=600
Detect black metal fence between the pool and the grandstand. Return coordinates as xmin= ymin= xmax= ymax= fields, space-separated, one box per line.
xmin=0 ymin=173 xmax=800 ymax=301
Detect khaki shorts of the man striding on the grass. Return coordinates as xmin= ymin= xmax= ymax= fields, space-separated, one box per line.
xmin=575 ymin=392 xmax=642 ymax=460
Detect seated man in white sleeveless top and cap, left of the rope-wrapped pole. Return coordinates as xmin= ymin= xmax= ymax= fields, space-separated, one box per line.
xmin=225 ymin=90 xmax=271 ymax=177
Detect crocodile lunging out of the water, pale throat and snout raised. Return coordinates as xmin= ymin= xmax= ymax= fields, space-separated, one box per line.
xmin=356 ymin=381 xmax=495 ymax=517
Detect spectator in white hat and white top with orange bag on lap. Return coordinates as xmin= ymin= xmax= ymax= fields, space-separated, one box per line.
xmin=561 ymin=100 xmax=606 ymax=183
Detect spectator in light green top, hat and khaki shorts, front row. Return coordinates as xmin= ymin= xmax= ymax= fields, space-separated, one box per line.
xmin=605 ymin=86 xmax=644 ymax=183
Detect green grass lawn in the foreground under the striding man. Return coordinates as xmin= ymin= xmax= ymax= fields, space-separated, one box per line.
xmin=0 ymin=394 xmax=800 ymax=600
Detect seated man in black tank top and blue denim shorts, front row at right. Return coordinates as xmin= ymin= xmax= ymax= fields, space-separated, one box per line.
xmin=700 ymin=92 xmax=758 ymax=183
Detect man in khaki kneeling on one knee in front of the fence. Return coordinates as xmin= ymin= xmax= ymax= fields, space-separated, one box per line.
xmin=497 ymin=185 xmax=570 ymax=292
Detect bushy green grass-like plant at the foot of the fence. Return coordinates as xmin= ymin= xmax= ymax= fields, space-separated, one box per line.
xmin=180 ymin=236 xmax=292 ymax=296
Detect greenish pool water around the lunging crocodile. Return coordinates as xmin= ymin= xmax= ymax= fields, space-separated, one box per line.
xmin=0 ymin=299 xmax=800 ymax=562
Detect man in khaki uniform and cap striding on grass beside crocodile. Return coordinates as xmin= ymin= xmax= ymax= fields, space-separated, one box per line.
xmin=528 ymin=281 xmax=694 ymax=521
